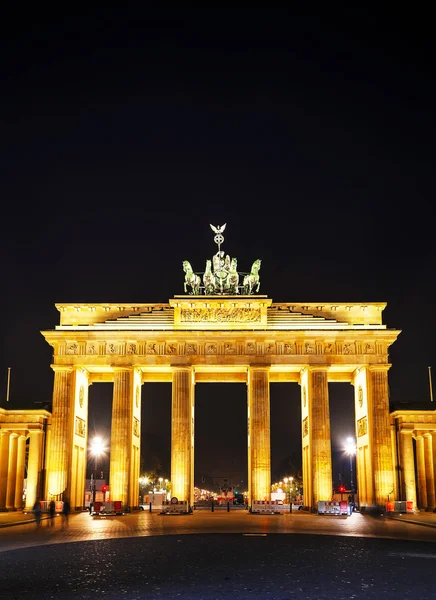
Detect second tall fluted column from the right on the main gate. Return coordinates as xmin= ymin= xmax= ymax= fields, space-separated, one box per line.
xmin=309 ymin=370 xmax=333 ymax=507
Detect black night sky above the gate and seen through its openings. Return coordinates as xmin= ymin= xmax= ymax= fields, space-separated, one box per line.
xmin=0 ymin=4 xmax=436 ymax=490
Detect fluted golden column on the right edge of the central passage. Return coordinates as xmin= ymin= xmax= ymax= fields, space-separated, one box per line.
xmin=248 ymin=367 xmax=271 ymax=505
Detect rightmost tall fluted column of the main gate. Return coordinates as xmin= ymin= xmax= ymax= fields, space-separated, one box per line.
xmin=369 ymin=365 xmax=395 ymax=507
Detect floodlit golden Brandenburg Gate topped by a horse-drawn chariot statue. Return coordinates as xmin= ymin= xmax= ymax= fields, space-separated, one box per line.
xmin=0 ymin=225 xmax=436 ymax=510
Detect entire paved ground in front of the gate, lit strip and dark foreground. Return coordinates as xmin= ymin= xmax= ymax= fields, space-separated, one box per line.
xmin=0 ymin=511 xmax=436 ymax=600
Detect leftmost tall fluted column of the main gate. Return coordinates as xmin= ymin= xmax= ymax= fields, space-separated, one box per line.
xmin=45 ymin=366 xmax=74 ymax=506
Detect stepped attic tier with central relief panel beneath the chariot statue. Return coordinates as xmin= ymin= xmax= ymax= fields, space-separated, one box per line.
xmin=52 ymin=295 xmax=386 ymax=331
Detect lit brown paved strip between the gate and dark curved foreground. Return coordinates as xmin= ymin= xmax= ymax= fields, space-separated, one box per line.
xmin=0 ymin=511 xmax=436 ymax=552
